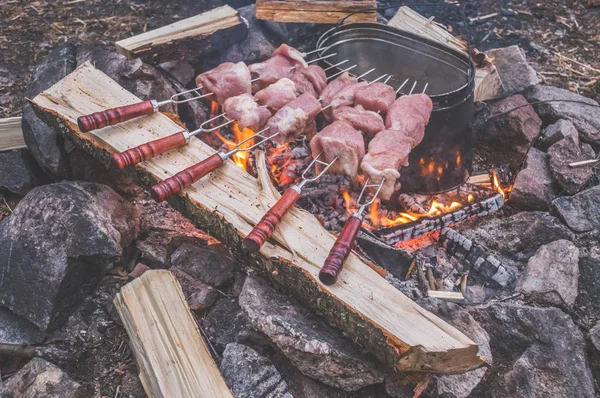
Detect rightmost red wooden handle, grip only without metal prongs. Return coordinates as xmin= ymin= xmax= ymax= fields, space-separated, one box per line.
xmin=319 ymin=216 xmax=362 ymax=285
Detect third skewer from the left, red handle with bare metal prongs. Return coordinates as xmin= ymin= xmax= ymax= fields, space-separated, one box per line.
xmin=152 ymin=128 xmax=279 ymax=202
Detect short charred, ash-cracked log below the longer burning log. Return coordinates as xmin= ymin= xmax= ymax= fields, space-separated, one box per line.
xmin=440 ymin=227 xmax=510 ymax=287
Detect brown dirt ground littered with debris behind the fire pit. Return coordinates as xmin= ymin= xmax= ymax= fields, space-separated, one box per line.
xmin=0 ymin=0 xmax=600 ymax=117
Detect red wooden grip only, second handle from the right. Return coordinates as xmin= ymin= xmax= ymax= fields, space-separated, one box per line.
xmin=244 ymin=188 xmax=300 ymax=252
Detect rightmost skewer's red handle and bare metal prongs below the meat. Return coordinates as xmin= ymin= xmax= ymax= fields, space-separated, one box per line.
xmin=319 ymin=178 xmax=385 ymax=285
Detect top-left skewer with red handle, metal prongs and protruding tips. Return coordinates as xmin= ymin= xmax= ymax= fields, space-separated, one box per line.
xmin=77 ymin=51 xmax=337 ymax=133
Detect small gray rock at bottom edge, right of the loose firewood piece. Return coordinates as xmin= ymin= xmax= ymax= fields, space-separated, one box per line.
xmin=221 ymin=343 xmax=292 ymax=398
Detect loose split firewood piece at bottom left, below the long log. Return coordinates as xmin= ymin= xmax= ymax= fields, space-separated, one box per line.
xmin=114 ymin=270 xmax=234 ymax=398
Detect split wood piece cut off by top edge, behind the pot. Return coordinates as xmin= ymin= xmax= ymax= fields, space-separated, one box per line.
xmin=256 ymin=0 xmax=377 ymax=24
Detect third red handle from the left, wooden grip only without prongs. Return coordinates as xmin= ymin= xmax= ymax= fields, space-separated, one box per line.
xmin=152 ymin=153 xmax=223 ymax=202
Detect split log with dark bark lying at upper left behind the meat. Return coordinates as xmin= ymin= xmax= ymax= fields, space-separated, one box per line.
xmin=115 ymin=5 xmax=248 ymax=64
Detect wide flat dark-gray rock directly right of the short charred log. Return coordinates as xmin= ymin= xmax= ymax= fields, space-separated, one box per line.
xmin=456 ymin=211 xmax=574 ymax=265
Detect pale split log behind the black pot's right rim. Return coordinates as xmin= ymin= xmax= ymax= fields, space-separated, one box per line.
xmin=388 ymin=6 xmax=503 ymax=101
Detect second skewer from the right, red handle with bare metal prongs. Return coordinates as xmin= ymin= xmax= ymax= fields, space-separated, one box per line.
xmin=244 ymin=152 xmax=337 ymax=252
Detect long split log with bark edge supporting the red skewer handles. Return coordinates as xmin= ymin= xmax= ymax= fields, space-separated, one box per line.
xmin=31 ymin=63 xmax=484 ymax=373
